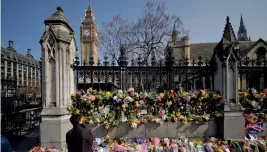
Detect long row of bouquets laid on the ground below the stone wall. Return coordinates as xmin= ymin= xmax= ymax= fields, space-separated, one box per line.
xmin=95 ymin=136 xmax=267 ymax=152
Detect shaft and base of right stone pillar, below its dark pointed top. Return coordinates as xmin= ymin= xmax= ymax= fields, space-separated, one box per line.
xmin=214 ymin=54 xmax=245 ymax=139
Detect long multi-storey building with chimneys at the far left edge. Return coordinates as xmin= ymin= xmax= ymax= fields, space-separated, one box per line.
xmin=1 ymin=41 xmax=41 ymax=89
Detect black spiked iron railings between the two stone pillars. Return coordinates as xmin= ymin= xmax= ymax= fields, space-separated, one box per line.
xmin=75 ymin=50 xmax=214 ymax=91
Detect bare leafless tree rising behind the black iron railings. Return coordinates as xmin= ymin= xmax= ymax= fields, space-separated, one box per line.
xmin=100 ymin=0 xmax=186 ymax=63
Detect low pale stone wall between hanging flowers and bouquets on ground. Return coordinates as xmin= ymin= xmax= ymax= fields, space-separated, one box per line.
xmin=90 ymin=121 xmax=217 ymax=138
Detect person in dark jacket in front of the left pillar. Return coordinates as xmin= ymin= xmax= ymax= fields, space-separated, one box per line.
xmin=66 ymin=115 xmax=94 ymax=152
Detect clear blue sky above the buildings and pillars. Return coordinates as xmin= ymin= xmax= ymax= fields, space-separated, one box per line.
xmin=1 ymin=0 xmax=267 ymax=59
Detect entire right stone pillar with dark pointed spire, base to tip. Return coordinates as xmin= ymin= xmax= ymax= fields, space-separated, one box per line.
xmin=212 ymin=17 xmax=245 ymax=139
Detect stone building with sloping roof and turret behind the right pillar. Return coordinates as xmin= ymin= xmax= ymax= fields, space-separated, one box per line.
xmin=168 ymin=16 xmax=267 ymax=61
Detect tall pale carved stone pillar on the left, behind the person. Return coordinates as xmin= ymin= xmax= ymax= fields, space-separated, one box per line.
xmin=40 ymin=7 xmax=77 ymax=149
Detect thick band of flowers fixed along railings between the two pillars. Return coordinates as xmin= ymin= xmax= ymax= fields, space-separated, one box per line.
xmin=68 ymin=88 xmax=223 ymax=129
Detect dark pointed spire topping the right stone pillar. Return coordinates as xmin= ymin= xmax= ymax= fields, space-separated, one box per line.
xmin=223 ymin=16 xmax=236 ymax=42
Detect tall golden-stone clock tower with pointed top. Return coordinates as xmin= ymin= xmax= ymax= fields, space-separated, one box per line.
xmin=80 ymin=1 xmax=98 ymax=65
